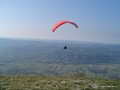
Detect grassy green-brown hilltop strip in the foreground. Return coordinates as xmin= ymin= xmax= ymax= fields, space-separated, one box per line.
xmin=0 ymin=75 xmax=120 ymax=90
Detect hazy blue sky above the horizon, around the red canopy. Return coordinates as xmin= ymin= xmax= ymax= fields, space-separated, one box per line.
xmin=0 ymin=0 xmax=120 ymax=44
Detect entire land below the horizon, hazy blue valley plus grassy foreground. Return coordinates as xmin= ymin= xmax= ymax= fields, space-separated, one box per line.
xmin=0 ymin=39 xmax=120 ymax=90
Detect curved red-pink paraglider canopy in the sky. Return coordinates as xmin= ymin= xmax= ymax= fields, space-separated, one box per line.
xmin=52 ymin=20 xmax=78 ymax=32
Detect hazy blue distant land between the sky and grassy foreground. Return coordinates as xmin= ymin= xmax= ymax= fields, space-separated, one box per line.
xmin=0 ymin=38 xmax=120 ymax=78
